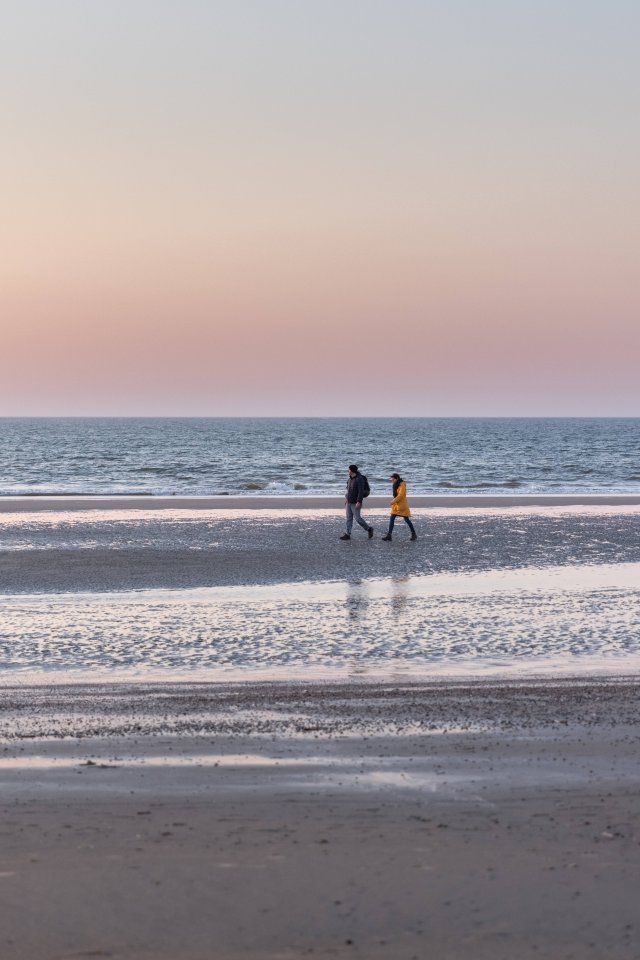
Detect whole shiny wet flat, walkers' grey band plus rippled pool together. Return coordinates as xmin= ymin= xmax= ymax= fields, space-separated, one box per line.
xmin=5 ymin=506 xmax=640 ymax=679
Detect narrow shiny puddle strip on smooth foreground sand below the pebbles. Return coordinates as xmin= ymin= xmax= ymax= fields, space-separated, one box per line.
xmin=0 ymin=738 xmax=603 ymax=802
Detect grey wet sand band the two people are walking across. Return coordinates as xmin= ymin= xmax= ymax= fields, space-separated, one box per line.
xmin=0 ymin=498 xmax=640 ymax=594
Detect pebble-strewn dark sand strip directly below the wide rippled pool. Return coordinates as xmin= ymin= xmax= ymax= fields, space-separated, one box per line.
xmin=0 ymin=675 xmax=640 ymax=744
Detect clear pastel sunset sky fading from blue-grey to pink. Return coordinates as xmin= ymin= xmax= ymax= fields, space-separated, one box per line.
xmin=0 ymin=0 xmax=640 ymax=416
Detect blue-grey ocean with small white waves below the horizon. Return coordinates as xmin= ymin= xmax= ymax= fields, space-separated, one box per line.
xmin=0 ymin=417 xmax=640 ymax=496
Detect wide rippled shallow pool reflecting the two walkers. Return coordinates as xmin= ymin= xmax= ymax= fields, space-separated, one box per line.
xmin=0 ymin=563 xmax=640 ymax=678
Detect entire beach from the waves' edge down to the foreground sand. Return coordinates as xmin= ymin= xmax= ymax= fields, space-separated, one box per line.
xmin=0 ymin=497 xmax=640 ymax=960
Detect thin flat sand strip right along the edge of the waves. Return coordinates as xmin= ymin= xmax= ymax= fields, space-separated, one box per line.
xmin=0 ymin=493 xmax=640 ymax=514
